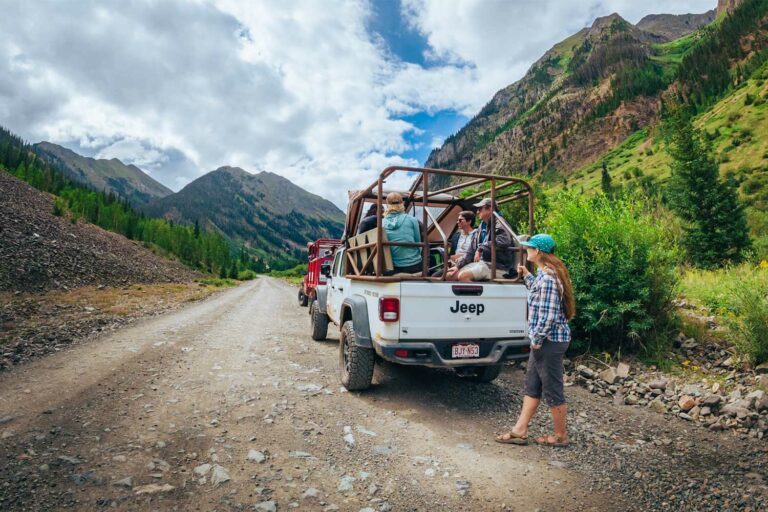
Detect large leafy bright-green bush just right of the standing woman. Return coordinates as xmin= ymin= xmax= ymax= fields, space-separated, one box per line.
xmin=545 ymin=193 xmax=678 ymax=352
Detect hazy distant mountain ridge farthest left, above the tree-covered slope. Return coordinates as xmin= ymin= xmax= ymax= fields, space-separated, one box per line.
xmin=34 ymin=142 xmax=173 ymax=206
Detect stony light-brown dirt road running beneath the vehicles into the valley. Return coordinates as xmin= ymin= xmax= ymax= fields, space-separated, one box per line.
xmin=0 ymin=278 xmax=764 ymax=511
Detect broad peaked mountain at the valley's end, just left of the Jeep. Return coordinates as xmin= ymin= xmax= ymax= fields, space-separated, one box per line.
xmin=142 ymin=167 xmax=344 ymax=255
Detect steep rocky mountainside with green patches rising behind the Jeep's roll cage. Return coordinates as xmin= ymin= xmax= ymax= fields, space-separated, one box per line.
xmin=426 ymin=1 xmax=762 ymax=182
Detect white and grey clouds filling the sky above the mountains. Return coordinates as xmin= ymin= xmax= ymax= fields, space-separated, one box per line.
xmin=0 ymin=0 xmax=714 ymax=207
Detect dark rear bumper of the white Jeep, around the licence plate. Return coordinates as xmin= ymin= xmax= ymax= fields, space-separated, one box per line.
xmin=374 ymin=338 xmax=530 ymax=368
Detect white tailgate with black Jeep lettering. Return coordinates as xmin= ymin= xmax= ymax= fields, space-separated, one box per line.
xmin=400 ymin=281 xmax=528 ymax=341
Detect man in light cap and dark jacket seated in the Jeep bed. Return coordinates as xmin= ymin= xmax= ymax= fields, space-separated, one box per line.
xmin=446 ymin=198 xmax=513 ymax=281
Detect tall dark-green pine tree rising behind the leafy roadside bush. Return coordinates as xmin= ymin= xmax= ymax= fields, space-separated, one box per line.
xmin=668 ymin=107 xmax=750 ymax=268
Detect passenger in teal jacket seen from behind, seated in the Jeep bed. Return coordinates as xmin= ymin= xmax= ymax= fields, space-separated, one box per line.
xmin=382 ymin=192 xmax=422 ymax=274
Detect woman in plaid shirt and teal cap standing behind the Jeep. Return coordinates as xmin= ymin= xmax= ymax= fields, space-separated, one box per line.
xmin=496 ymin=234 xmax=576 ymax=446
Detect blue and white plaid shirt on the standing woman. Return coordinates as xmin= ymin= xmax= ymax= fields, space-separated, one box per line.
xmin=525 ymin=269 xmax=571 ymax=345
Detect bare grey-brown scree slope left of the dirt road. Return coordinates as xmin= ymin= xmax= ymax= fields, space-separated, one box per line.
xmin=0 ymin=172 xmax=197 ymax=292
